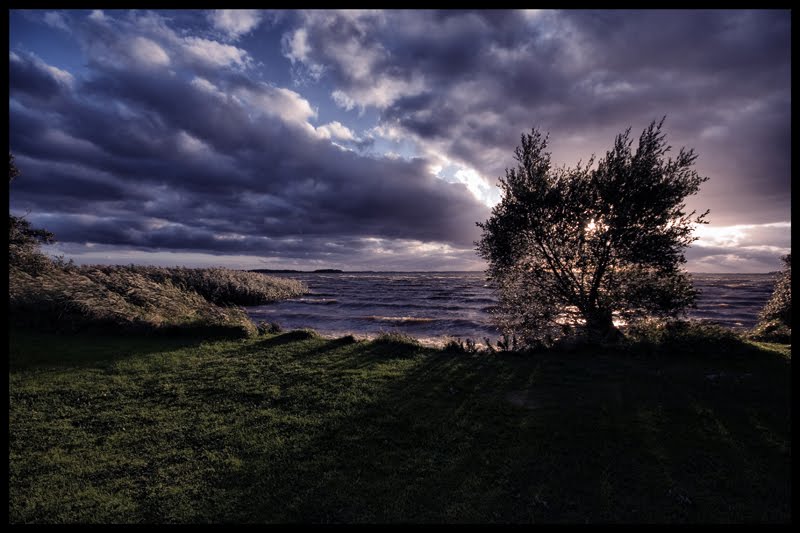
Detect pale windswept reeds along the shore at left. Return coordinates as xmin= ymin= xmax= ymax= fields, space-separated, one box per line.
xmin=9 ymin=261 xmax=307 ymax=337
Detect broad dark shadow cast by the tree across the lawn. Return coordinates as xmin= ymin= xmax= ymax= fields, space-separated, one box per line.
xmin=202 ymin=343 xmax=791 ymax=523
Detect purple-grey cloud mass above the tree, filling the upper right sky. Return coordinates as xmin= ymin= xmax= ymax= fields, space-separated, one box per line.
xmin=285 ymin=10 xmax=791 ymax=224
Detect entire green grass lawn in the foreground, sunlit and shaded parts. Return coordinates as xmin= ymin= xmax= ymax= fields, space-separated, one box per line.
xmin=9 ymin=330 xmax=791 ymax=523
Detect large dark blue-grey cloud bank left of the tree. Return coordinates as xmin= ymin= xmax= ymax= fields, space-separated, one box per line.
xmin=10 ymin=21 xmax=488 ymax=264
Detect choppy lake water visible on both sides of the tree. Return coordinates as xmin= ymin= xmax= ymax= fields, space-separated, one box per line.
xmin=247 ymin=272 xmax=775 ymax=344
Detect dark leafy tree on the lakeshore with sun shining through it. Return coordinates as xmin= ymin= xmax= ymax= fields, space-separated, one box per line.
xmin=476 ymin=119 xmax=708 ymax=346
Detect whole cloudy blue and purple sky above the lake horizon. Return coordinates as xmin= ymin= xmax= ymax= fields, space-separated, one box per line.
xmin=9 ymin=10 xmax=791 ymax=272
